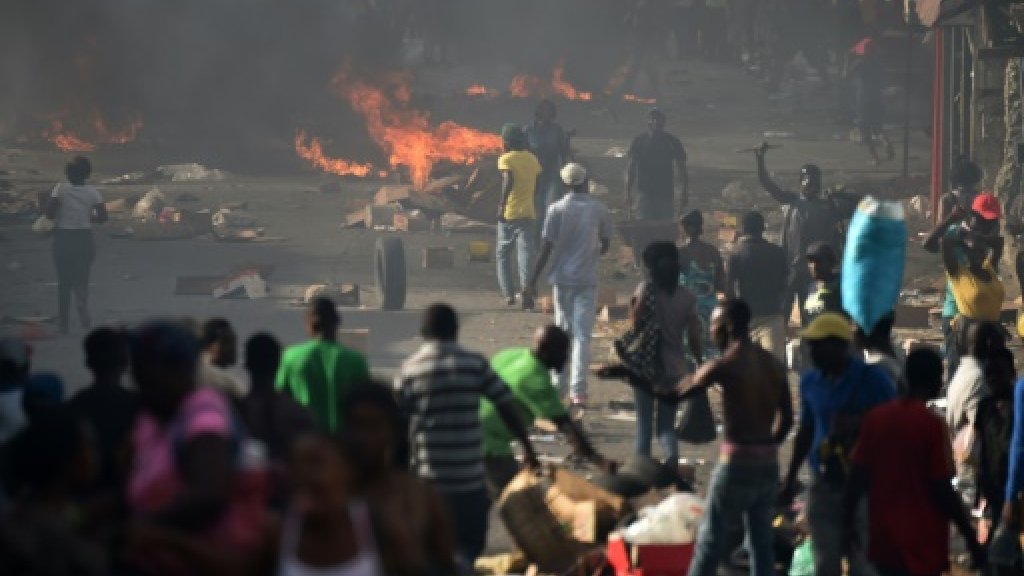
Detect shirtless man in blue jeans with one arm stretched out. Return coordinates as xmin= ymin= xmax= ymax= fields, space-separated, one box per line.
xmin=631 ymin=300 xmax=793 ymax=576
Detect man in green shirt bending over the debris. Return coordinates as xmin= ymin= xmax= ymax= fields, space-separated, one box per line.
xmin=480 ymin=325 xmax=613 ymax=497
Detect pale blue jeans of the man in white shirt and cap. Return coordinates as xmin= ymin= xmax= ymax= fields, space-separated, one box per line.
xmin=554 ymin=284 xmax=597 ymax=400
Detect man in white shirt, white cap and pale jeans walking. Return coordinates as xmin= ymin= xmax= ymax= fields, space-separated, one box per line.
xmin=523 ymin=162 xmax=611 ymax=409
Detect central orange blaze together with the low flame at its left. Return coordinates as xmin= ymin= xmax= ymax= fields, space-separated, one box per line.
xmin=295 ymin=71 xmax=502 ymax=190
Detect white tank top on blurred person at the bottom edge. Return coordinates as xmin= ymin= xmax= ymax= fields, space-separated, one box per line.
xmin=278 ymin=500 xmax=384 ymax=576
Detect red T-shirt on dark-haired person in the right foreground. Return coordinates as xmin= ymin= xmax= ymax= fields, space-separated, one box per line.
xmin=853 ymin=399 xmax=953 ymax=575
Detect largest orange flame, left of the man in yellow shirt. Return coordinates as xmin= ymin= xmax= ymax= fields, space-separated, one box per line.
xmin=332 ymin=72 xmax=502 ymax=188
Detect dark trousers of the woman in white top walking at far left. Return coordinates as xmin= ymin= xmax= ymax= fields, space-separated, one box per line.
xmin=53 ymin=229 xmax=96 ymax=332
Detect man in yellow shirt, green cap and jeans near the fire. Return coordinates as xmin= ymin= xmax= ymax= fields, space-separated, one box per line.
xmin=495 ymin=124 xmax=541 ymax=310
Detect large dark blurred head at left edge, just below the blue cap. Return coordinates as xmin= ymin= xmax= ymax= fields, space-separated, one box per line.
xmin=0 ymin=405 xmax=97 ymax=498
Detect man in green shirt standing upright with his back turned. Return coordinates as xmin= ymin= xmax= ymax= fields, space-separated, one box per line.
xmin=275 ymin=297 xmax=370 ymax=433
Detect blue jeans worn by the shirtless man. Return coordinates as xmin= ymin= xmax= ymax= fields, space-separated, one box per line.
xmin=689 ymin=461 xmax=778 ymax=576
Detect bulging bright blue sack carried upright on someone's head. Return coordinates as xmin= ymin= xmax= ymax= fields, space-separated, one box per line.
xmin=842 ymin=196 xmax=906 ymax=333
